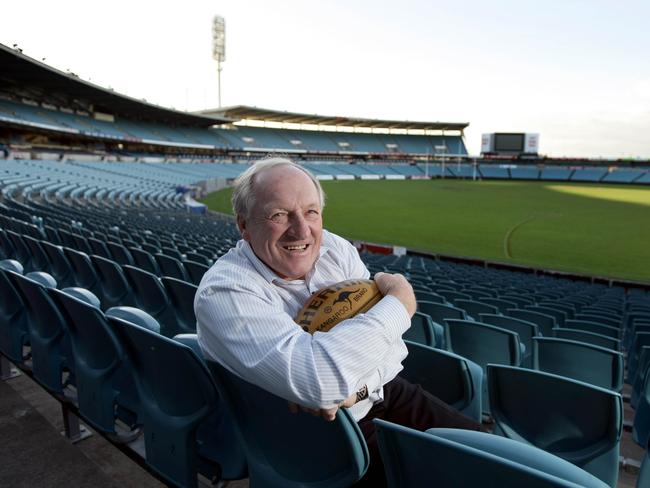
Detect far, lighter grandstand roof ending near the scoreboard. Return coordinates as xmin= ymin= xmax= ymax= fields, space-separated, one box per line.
xmin=198 ymin=105 xmax=469 ymax=131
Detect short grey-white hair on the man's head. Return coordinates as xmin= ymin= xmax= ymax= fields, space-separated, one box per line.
xmin=231 ymin=157 xmax=325 ymax=218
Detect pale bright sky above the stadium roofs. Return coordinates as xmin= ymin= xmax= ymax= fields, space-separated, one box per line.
xmin=0 ymin=0 xmax=650 ymax=158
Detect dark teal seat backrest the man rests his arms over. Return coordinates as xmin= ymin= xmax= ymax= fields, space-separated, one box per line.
xmin=207 ymin=360 xmax=369 ymax=488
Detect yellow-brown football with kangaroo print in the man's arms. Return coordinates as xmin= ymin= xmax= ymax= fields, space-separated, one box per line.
xmin=296 ymin=280 xmax=382 ymax=334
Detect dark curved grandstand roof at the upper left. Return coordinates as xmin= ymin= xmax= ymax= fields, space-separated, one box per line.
xmin=0 ymin=44 xmax=232 ymax=127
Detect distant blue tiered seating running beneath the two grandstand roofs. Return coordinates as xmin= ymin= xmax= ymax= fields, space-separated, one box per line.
xmin=0 ymin=98 xmax=467 ymax=155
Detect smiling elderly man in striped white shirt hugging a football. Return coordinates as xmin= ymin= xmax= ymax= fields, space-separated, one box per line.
xmin=194 ymin=158 xmax=480 ymax=486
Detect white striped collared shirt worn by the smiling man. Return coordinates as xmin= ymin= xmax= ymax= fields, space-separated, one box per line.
xmin=194 ymin=230 xmax=411 ymax=420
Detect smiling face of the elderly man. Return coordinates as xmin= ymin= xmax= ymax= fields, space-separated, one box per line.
xmin=237 ymin=166 xmax=323 ymax=280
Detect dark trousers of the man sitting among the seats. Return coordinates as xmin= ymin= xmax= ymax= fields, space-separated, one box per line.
xmin=355 ymin=376 xmax=481 ymax=488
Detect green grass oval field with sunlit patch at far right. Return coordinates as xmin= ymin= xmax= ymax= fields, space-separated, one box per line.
xmin=204 ymin=180 xmax=650 ymax=282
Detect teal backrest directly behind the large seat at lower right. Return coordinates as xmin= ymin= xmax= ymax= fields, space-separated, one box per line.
xmin=533 ymin=337 xmax=623 ymax=392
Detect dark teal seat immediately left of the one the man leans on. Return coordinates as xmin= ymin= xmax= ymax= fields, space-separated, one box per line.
xmin=106 ymin=307 xmax=246 ymax=487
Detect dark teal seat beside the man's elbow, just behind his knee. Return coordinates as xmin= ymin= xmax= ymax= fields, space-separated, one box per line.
xmin=400 ymin=341 xmax=483 ymax=422
